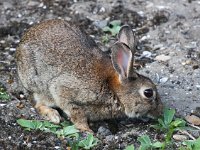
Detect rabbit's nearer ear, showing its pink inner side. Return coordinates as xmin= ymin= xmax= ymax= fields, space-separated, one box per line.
xmin=111 ymin=42 xmax=137 ymax=79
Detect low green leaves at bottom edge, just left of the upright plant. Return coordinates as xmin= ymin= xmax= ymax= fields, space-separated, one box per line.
xmin=138 ymin=135 xmax=163 ymax=150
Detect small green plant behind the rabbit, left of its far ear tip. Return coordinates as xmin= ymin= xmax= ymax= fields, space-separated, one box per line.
xmin=102 ymin=20 xmax=121 ymax=43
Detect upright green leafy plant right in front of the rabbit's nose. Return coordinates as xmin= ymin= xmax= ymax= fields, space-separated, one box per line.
xmin=152 ymin=108 xmax=186 ymax=150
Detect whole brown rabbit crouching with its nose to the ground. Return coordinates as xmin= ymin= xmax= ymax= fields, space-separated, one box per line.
xmin=16 ymin=20 xmax=162 ymax=131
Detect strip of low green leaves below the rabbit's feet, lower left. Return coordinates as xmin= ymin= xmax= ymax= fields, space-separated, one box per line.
xmin=17 ymin=119 xmax=98 ymax=150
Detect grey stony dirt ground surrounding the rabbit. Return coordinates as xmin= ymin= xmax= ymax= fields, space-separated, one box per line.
xmin=0 ymin=0 xmax=200 ymax=150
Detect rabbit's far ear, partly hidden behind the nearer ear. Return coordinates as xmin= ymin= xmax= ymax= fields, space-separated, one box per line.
xmin=118 ymin=25 xmax=135 ymax=50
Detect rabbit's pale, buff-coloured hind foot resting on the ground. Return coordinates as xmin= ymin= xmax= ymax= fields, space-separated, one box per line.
xmin=33 ymin=93 xmax=61 ymax=124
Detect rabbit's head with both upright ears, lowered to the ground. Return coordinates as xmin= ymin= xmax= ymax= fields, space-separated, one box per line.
xmin=111 ymin=26 xmax=162 ymax=118
